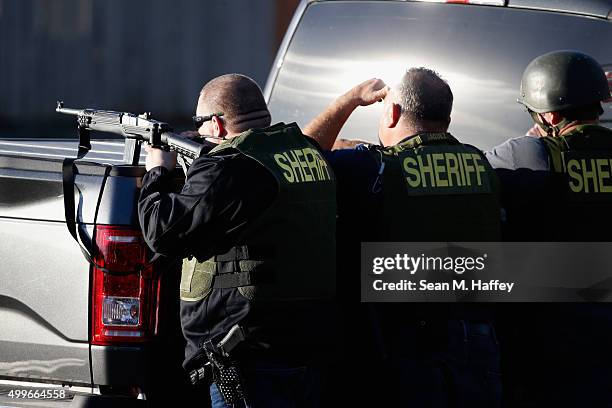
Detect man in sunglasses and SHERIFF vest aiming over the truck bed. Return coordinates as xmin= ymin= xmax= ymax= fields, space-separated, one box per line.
xmin=138 ymin=74 xmax=336 ymax=407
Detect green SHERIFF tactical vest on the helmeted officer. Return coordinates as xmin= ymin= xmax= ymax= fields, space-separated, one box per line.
xmin=540 ymin=125 xmax=612 ymax=241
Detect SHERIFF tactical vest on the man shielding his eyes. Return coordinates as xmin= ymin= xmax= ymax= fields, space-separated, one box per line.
xmin=370 ymin=133 xmax=500 ymax=242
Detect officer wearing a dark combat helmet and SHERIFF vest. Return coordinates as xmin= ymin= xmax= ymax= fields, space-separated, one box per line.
xmin=487 ymin=50 xmax=612 ymax=407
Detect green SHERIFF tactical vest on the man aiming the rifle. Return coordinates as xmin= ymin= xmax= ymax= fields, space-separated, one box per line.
xmin=180 ymin=124 xmax=336 ymax=302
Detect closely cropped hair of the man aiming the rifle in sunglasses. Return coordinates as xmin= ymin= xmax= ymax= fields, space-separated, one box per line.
xmin=197 ymin=74 xmax=270 ymax=131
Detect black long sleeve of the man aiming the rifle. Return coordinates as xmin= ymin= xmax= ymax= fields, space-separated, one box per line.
xmin=138 ymin=143 xmax=278 ymax=260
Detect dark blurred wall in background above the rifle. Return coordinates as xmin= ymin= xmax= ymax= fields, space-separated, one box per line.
xmin=0 ymin=0 xmax=298 ymax=137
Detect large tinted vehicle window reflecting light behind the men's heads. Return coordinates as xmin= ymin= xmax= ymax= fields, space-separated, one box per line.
xmin=270 ymin=2 xmax=612 ymax=149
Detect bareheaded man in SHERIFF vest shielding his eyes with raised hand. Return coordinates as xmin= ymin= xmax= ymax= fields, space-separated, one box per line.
xmin=304 ymin=68 xmax=501 ymax=407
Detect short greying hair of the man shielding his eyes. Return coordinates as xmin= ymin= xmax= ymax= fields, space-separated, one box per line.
xmin=397 ymin=67 xmax=453 ymax=125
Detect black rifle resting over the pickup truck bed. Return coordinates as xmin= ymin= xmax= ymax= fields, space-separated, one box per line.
xmin=55 ymin=101 xmax=204 ymax=165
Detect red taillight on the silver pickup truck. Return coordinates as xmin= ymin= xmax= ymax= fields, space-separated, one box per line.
xmin=92 ymin=225 xmax=159 ymax=345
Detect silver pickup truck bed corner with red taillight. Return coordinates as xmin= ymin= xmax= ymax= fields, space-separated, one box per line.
xmin=0 ymin=139 xmax=189 ymax=406
